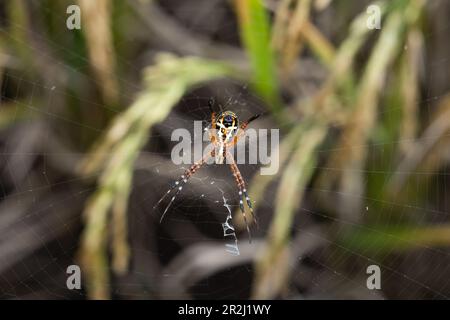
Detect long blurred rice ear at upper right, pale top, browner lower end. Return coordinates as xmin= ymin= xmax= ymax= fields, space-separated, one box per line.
xmin=321 ymin=12 xmax=404 ymax=218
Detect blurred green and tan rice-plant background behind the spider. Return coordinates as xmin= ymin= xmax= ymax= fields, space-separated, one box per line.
xmin=0 ymin=0 xmax=450 ymax=299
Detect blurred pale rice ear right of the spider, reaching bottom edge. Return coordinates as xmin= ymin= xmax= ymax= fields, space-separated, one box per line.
xmin=252 ymin=119 xmax=328 ymax=299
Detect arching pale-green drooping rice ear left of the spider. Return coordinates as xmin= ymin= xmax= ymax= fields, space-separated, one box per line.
xmin=79 ymin=55 xmax=236 ymax=299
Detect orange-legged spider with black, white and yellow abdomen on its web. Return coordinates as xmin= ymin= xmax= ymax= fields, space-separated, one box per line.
xmin=155 ymin=99 xmax=260 ymax=242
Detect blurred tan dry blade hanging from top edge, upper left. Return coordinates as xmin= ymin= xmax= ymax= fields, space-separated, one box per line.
xmin=78 ymin=0 xmax=119 ymax=105
